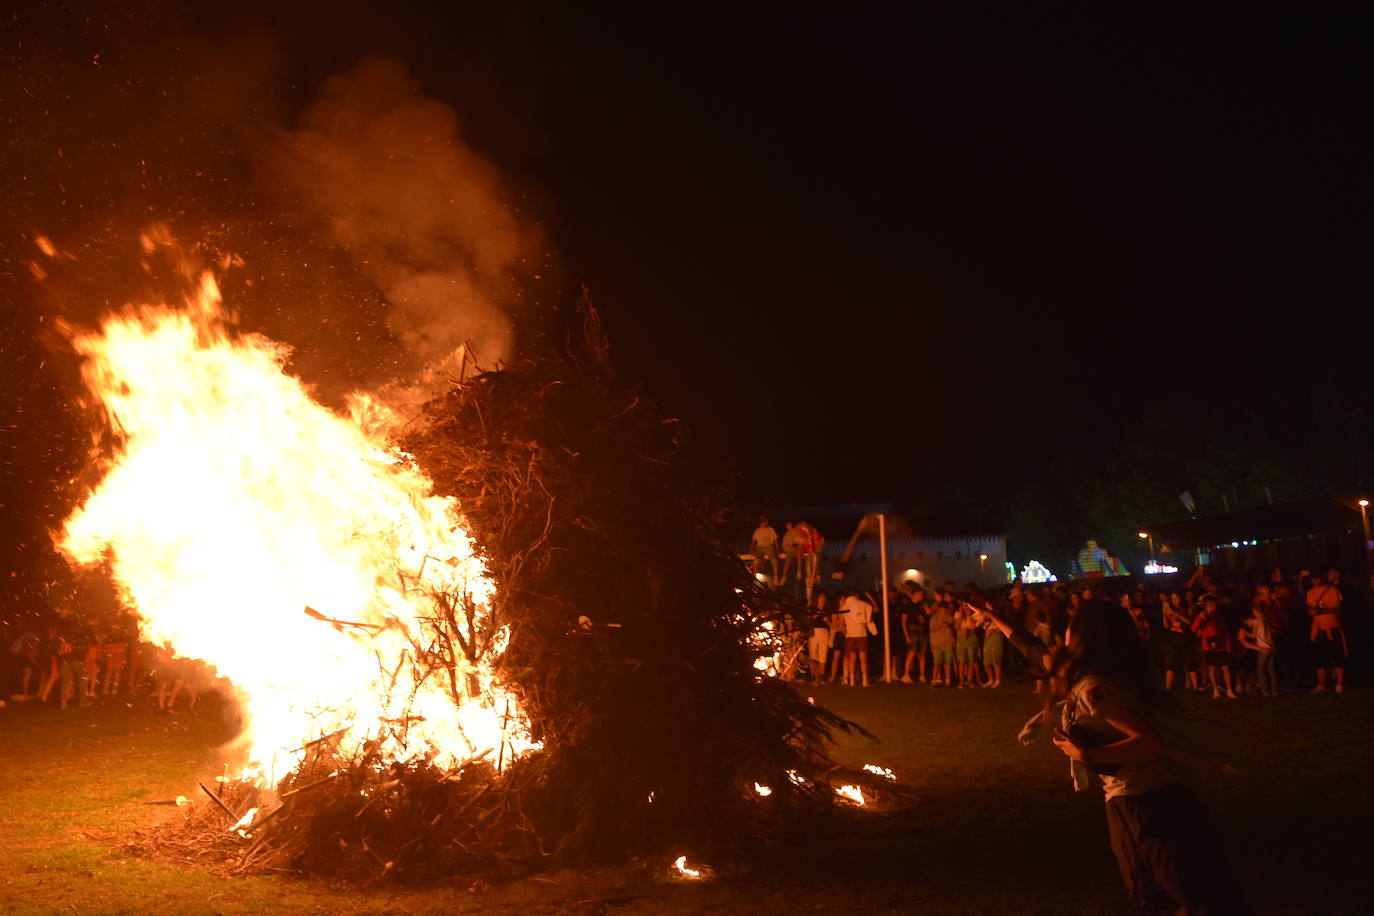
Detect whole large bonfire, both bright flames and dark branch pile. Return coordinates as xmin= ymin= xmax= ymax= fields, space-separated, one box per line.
xmin=44 ymin=232 xmax=882 ymax=875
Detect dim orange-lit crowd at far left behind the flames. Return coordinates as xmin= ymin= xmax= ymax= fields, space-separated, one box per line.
xmin=0 ymin=607 xmax=216 ymax=713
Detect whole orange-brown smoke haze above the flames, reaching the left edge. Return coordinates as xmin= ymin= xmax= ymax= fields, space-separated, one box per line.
xmin=0 ymin=3 xmax=552 ymax=615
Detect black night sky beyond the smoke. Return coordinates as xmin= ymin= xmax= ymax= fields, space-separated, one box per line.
xmin=5 ymin=3 xmax=1371 ymax=543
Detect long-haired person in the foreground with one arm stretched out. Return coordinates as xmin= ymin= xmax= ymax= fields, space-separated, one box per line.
xmin=978 ymin=600 xmax=1243 ymax=913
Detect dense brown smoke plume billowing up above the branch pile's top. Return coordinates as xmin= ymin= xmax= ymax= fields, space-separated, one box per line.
xmin=271 ymin=59 xmax=539 ymax=367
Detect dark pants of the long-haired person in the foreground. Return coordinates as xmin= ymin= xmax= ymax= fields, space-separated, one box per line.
xmin=1107 ymin=784 xmax=1245 ymax=916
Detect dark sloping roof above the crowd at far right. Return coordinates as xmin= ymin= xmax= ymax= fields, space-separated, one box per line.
xmin=1142 ymin=499 xmax=1362 ymax=549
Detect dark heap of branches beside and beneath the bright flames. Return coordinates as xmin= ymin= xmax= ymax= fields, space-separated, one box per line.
xmin=142 ymin=304 xmax=890 ymax=878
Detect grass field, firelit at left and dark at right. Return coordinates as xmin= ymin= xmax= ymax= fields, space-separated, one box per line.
xmin=0 ymin=684 xmax=1374 ymax=915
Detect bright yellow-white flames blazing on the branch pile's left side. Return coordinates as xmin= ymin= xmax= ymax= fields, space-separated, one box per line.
xmin=60 ymin=238 xmax=533 ymax=781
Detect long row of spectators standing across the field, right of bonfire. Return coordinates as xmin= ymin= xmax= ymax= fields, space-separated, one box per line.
xmin=783 ymin=567 xmax=1374 ymax=699
